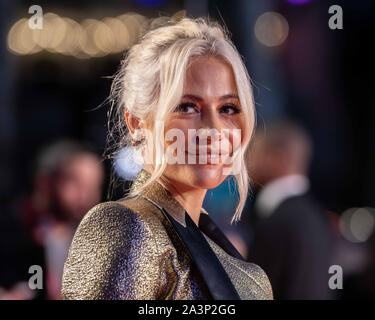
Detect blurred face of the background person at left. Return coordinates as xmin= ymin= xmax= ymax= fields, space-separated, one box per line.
xmin=55 ymin=154 xmax=104 ymax=220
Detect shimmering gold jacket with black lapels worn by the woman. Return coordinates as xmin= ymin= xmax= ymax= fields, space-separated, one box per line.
xmin=62 ymin=170 xmax=273 ymax=300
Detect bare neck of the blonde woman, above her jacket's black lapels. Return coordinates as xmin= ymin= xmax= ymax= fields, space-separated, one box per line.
xmin=159 ymin=177 xmax=207 ymax=226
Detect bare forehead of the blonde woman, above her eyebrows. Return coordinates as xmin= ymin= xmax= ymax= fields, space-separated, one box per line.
xmin=184 ymin=57 xmax=237 ymax=96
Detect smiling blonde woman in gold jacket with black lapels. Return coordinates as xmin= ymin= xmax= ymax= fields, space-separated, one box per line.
xmin=62 ymin=18 xmax=272 ymax=300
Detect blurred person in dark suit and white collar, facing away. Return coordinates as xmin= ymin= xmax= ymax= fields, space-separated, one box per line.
xmin=248 ymin=121 xmax=335 ymax=299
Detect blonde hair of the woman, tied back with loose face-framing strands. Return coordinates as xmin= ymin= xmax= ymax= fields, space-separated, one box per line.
xmin=108 ymin=18 xmax=255 ymax=222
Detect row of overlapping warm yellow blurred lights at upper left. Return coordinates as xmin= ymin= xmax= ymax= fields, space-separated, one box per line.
xmin=7 ymin=12 xmax=150 ymax=59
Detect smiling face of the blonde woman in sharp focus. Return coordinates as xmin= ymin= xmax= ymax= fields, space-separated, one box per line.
xmin=159 ymin=57 xmax=250 ymax=189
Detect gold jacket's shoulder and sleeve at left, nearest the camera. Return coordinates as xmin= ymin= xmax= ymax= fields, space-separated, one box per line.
xmin=62 ymin=200 xmax=165 ymax=299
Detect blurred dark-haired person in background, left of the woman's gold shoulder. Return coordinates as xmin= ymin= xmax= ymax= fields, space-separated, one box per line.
xmin=18 ymin=140 xmax=104 ymax=299
